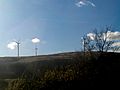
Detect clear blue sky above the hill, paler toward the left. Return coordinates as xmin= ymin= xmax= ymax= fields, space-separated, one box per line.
xmin=0 ymin=0 xmax=120 ymax=56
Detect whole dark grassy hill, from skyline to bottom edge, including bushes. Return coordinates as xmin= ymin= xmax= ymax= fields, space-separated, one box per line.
xmin=0 ymin=52 xmax=120 ymax=90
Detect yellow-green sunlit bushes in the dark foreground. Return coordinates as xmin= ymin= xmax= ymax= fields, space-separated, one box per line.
xmin=8 ymin=57 xmax=98 ymax=90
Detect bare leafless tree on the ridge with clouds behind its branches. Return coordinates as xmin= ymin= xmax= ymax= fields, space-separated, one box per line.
xmin=82 ymin=27 xmax=120 ymax=53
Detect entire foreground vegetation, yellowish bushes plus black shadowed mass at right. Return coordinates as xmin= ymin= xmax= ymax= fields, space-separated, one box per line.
xmin=5 ymin=52 xmax=120 ymax=90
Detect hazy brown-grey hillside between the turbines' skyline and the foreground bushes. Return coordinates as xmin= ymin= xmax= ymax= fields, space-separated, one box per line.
xmin=0 ymin=52 xmax=79 ymax=90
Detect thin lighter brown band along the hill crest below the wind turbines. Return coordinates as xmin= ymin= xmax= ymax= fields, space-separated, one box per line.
xmin=0 ymin=52 xmax=80 ymax=63
